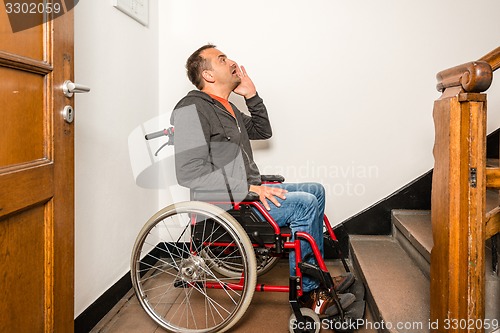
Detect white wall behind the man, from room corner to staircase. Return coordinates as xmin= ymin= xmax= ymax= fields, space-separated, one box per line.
xmin=159 ymin=0 xmax=500 ymax=223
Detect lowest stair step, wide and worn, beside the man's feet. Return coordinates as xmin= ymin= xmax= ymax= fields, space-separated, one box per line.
xmin=350 ymin=235 xmax=430 ymax=332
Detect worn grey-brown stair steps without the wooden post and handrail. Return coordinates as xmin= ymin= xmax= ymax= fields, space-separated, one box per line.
xmin=350 ymin=191 xmax=500 ymax=333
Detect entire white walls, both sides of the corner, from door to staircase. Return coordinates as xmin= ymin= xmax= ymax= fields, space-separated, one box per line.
xmin=75 ymin=0 xmax=500 ymax=317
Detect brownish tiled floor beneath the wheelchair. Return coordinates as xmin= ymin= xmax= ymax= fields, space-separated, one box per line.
xmin=91 ymin=260 xmax=376 ymax=333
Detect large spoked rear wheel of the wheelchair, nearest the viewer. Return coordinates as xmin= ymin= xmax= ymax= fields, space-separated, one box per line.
xmin=131 ymin=201 xmax=257 ymax=333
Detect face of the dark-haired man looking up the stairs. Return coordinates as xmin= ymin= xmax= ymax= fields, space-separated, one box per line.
xmin=201 ymin=48 xmax=241 ymax=90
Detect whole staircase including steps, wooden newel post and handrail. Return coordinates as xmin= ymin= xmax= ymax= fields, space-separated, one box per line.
xmin=350 ymin=47 xmax=500 ymax=333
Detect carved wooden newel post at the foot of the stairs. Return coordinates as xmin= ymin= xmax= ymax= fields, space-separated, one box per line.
xmin=429 ymin=61 xmax=492 ymax=332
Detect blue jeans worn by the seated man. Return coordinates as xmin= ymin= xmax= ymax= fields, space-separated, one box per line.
xmin=265 ymin=183 xmax=325 ymax=292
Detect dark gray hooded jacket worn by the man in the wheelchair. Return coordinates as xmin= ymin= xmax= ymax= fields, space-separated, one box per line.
xmin=170 ymin=90 xmax=272 ymax=197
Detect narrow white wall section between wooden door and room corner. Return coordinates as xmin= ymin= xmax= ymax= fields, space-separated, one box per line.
xmin=75 ymin=0 xmax=158 ymax=317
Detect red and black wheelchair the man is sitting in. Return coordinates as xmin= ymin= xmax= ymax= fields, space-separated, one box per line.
xmin=130 ymin=128 xmax=364 ymax=333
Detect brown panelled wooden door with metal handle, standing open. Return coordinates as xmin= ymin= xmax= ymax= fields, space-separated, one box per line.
xmin=0 ymin=0 xmax=74 ymax=333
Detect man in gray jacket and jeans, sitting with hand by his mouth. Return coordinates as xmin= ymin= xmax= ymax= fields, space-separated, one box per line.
xmin=172 ymin=44 xmax=355 ymax=315
